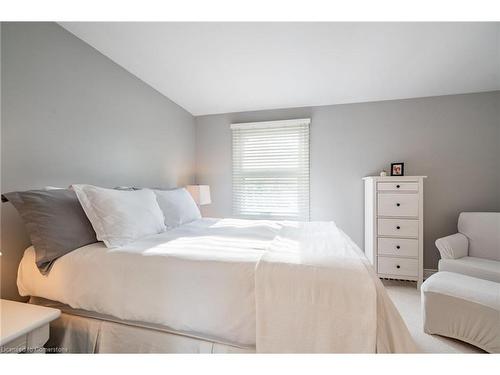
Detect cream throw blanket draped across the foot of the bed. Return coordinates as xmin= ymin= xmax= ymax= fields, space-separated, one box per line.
xmin=255 ymin=222 xmax=416 ymax=353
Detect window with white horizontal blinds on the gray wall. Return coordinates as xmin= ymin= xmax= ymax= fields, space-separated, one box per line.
xmin=231 ymin=119 xmax=311 ymax=221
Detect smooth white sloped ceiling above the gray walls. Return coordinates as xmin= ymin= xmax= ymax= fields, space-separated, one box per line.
xmin=60 ymin=22 xmax=500 ymax=115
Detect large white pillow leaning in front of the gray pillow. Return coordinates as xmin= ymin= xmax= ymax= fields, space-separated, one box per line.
xmin=71 ymin=185 xmax=166 ymax=247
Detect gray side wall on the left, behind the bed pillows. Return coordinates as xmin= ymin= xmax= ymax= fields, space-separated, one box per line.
xmin=1 ymin=22 xmax=195 ymax=298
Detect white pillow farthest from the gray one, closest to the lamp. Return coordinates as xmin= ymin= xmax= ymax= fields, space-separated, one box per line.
xmin=154 ymin=188 xmax=201 ymax=229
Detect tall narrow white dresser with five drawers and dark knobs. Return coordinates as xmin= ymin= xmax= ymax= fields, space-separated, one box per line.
xmin=363 ymin=176 xmax=426 ymax=288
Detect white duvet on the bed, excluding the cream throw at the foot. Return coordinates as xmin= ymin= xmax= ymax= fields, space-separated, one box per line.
xmin=18 ymin=218 xmax=280 ymax=347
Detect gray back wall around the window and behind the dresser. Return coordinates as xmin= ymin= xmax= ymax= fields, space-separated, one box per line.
xmin=196 ymin=92 xmax=500 ymax=268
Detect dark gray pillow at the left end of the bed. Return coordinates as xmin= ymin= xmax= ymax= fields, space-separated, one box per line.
xmin=4 ymin=189 xmax=97 ymax=274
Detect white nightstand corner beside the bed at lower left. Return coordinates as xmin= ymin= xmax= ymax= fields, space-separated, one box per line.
xmin=0 ymin=299 xmax=61 ymax=353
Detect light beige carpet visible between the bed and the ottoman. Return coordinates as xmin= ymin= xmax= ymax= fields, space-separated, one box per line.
xmin=382 ymin=280 xmax=484 ymax=353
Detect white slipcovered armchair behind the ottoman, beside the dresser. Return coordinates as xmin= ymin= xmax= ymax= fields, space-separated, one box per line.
xmin=436 ymin=212 xmax=500 ymax=283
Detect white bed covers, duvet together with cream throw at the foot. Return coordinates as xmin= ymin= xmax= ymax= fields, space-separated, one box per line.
xmin=18 ymin=219 xmax=415 ymax=352
